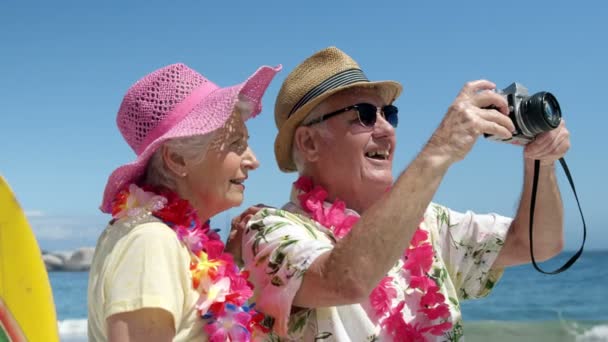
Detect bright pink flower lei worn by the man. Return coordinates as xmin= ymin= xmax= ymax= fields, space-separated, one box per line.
xmin=294 ymin=176 xmax=452 ymax=341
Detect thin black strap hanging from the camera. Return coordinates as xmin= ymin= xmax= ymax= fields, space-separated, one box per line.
xmin=530 ymin=158 xmax=587 ymax=274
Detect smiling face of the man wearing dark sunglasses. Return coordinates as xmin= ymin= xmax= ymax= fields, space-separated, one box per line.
xmin=311 ymin=88 xmax=396 ymax=211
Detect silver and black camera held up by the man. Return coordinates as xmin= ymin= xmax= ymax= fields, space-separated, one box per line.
xmin=485 ymin=83 xmax=562 ymax=145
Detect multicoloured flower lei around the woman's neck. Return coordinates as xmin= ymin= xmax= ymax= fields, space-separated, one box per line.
xmin=112 ymin=184 xmax=267 ymax=342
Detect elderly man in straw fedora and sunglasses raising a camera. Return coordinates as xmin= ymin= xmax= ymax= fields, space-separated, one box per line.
xmin=242 ymin=47 xmax=570 ymax=341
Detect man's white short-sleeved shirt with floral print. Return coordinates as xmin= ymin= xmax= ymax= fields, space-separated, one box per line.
xmin=243 ymin=188 xmax=511 ymax=341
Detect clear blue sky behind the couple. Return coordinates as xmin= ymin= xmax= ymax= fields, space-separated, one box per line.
xmin=0 ymin=0 xmax=608 ymax=249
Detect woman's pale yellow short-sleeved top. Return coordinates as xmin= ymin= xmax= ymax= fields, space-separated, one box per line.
xmin=88 ymin=216 xmax=207 ymax=341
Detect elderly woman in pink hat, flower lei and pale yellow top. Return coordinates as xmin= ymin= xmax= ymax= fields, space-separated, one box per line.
xmin=88 ymin=64 xmax=280 ymax=341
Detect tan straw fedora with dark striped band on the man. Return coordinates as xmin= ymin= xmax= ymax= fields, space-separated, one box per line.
xmin=274 ymin=46 xmax=402 ymax=172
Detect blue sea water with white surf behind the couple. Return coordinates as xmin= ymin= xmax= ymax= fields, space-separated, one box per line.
xmin=49 ymin=251 xmax=608 ymax=342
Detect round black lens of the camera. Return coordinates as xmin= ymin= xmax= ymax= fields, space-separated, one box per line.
xmin=520 ymin=91 xmax=562 ymax=136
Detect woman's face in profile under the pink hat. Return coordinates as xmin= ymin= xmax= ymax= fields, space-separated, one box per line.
xmin=180 ymin=112 xmax=260 ymax=219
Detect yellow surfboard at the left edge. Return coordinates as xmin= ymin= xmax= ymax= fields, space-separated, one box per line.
xmin=0 ymin=176 xmax=59 ymax=342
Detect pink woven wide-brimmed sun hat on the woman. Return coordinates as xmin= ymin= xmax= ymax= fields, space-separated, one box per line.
xmin=100 ymin=64 xmax=281 ymax=213
